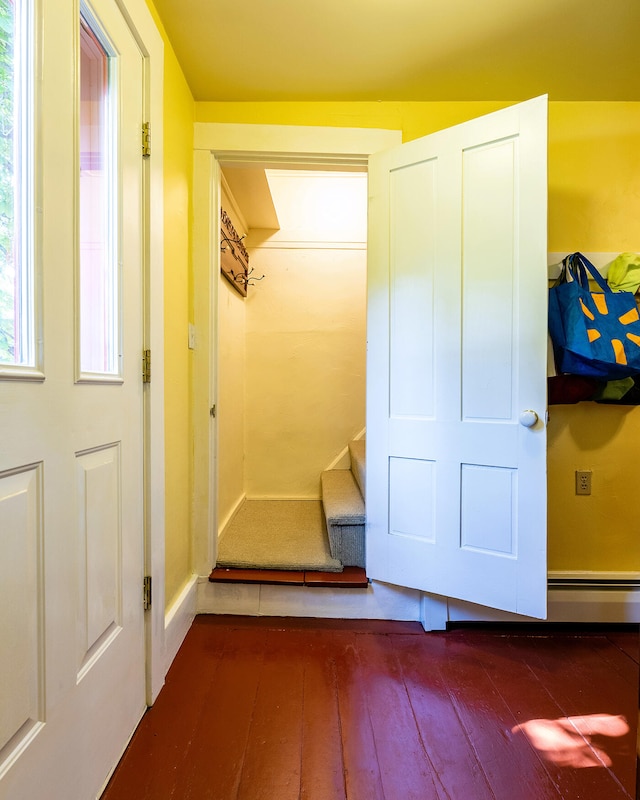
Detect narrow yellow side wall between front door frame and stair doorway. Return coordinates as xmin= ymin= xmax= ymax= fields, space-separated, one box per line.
xmin=148 ymin=0 xmax=195 ymax=608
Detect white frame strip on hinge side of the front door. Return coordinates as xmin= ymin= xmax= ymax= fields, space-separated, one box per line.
xmin=116 ymin=0 xmax=169 ymax=705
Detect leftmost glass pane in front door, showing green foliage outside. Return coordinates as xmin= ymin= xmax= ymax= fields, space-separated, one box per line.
xmin=0 ymin=0 xmax=35 ymax=366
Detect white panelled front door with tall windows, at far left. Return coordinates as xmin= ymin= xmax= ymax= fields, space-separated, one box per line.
xmin=0 ymin=0 xmax=145 ymax=800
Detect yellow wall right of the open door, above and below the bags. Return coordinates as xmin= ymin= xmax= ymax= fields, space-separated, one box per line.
xmin=548 ymin=103 xmax=640 ymax=571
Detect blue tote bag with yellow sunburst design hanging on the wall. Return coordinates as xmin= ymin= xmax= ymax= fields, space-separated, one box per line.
xmin=549 ymin=253 xmax=640 ymax=381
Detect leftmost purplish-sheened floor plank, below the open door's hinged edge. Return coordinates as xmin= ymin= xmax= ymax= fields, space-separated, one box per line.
xmin=357 ymin=634 xmax=446 ymax=800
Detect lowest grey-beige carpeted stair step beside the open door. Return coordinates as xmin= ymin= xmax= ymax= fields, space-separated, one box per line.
xmin=320 ymin=469 xmax=365 ymax=567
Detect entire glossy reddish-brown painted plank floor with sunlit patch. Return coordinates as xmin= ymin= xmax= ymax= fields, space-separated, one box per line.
xmin=103 ymin=616 xmax=638 ymax=800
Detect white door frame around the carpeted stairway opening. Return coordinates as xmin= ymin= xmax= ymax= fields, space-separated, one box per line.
xmin=193 ymin=122 xmax=402 ymax=576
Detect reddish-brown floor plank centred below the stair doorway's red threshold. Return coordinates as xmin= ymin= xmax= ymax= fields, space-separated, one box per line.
xmin=237 ymin=630 xmax=304 ymax=800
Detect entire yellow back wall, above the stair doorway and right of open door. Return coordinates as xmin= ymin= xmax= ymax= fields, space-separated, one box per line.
xmin=196 ymin=102 xmax=640 ymax=571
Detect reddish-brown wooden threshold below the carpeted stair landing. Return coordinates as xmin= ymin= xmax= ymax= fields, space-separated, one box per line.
xmin=209 ymin=567 xmax=369 ymax=589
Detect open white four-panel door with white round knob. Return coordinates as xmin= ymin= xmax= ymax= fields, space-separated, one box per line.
xmin=366 ymin=97 xmax=547 ymax=618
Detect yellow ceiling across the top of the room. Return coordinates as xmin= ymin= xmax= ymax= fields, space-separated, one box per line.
xmin=153 ymin=0 xmax=640 ymax=101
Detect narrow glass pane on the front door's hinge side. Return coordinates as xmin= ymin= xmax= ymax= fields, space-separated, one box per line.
xmin=80 ymin=19 xmax=119 ymax=375
